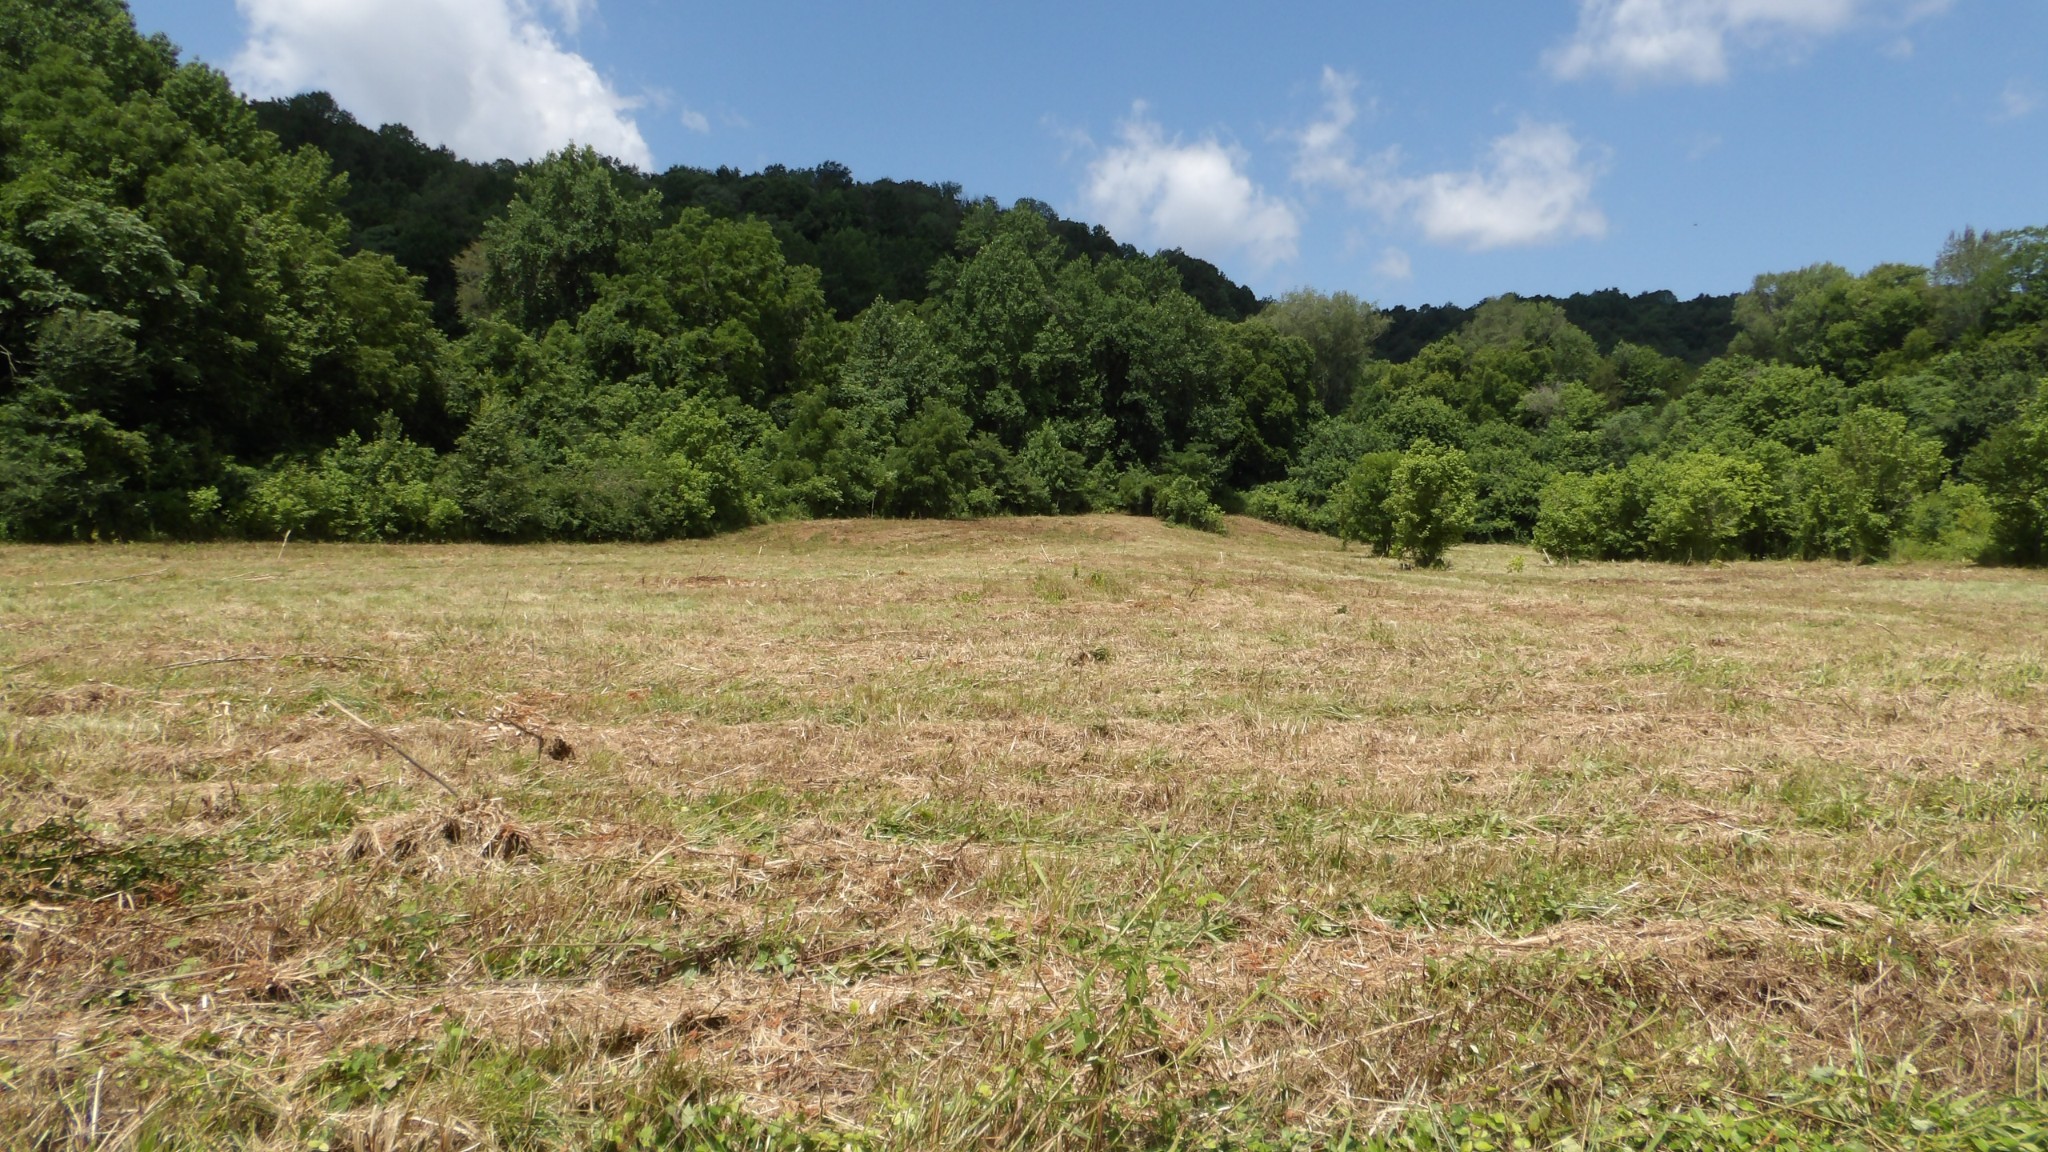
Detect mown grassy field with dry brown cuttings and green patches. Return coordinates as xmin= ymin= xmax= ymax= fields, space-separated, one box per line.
xmin=0 ymin=517 xmax=2048 ymax=1152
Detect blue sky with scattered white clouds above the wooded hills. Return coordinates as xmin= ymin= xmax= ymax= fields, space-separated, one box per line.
xmin=131 ymin=0 xmax=2048 ymax=305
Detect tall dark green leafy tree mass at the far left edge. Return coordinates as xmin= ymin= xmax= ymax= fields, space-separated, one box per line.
xmin=0 ymin=0 xmax=446 ymax=539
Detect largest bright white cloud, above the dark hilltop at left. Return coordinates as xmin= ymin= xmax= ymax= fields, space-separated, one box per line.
xmin=229 ymin=0 xmax=653 ymax=168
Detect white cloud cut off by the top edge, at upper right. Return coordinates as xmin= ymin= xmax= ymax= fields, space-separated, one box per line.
xmin=1544 ymin=0 xmax=1954 ymax=84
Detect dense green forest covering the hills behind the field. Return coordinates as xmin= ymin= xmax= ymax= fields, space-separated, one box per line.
xmin=0 ymin=0 xmax=2048 ymax=564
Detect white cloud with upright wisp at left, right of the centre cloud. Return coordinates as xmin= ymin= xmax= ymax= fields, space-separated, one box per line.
xmin=1294 ymin=70 xmax=1608 ymax=252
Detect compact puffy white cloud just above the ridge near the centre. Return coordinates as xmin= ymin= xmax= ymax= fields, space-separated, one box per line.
xmin=1081 ymin=105 xmax=1300 ymax=266
